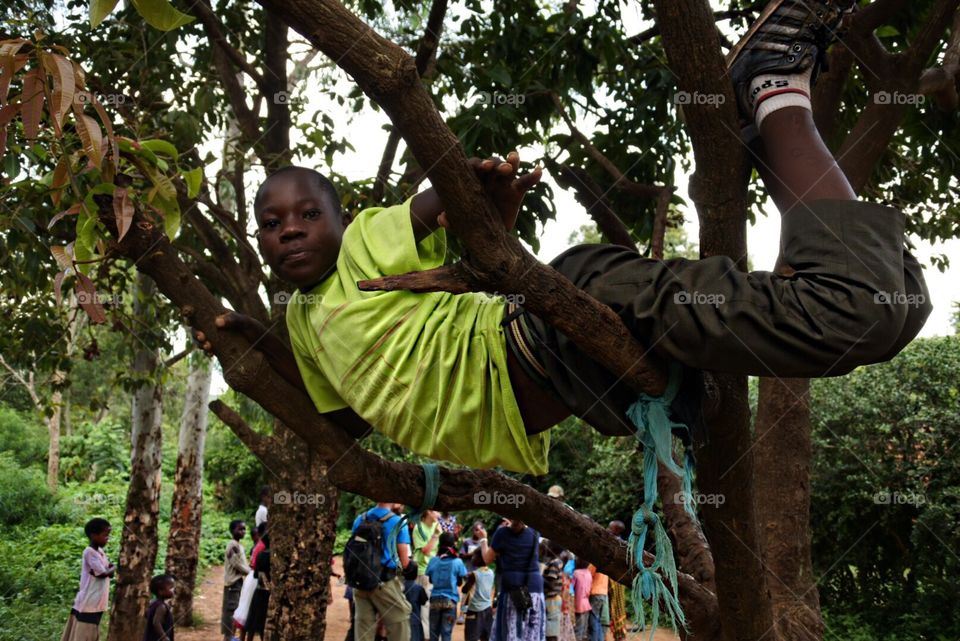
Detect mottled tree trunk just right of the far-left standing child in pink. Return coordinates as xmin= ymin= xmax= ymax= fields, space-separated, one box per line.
xmin=107 ymin=274 xmax=162 ymax=641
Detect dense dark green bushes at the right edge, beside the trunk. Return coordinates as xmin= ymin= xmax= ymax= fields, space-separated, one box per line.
xmin=811 ymin=336 xmax=960 ymax=639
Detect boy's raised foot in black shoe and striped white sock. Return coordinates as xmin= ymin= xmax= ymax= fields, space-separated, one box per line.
xmin=727 ymin=0 xmax=856 ymax=126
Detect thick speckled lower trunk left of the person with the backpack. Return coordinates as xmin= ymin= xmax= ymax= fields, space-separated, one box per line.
xmin=266 ymin=425 xmax=339 ymax=641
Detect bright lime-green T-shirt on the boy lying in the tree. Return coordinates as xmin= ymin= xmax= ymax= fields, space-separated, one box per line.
xmin=287 ymin=200 xmax=550 ymax=475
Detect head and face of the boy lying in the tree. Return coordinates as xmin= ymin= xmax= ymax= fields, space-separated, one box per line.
xmin=254 ymin=170 xmax=346 ymax=289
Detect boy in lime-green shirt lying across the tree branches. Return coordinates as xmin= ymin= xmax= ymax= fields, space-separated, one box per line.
xmin=197 ymin=0 xmax=930 ymax=474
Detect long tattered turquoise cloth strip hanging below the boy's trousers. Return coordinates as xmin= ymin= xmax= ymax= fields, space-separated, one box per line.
xmin=627 ymin=363 xmax=697 ymax=640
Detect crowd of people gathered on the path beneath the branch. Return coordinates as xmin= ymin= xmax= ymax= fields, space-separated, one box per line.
xmin=346 ymin=486 xmax=628 ymax=641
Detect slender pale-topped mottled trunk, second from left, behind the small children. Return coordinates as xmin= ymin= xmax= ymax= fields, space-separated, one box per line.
xmin=166 ymin=354 xmax=212 ymax=626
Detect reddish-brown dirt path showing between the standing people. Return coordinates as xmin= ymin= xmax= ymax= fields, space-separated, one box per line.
xmin=177 ymin=557 xmax=679 ymax=641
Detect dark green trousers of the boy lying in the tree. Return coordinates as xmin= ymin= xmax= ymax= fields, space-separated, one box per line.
xmin=525 ymin=200 xmax=931 ymax=434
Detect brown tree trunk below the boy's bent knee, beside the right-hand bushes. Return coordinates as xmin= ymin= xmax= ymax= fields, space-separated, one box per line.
xmin=754 ymin=378 xmax=823 ymax=641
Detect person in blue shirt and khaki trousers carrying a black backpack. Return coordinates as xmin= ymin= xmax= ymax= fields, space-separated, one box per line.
xmin=353 ymin=503 xmax=410 ymax=641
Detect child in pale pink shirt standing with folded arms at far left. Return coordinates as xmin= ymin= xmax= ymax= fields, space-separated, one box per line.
xmin=61 ymin=518 xmax=117 ymax=641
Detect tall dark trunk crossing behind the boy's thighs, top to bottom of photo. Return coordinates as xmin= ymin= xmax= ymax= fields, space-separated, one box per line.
xmin=654 ymin=0 xmax=773 ymax=641
